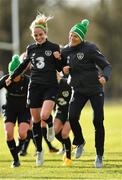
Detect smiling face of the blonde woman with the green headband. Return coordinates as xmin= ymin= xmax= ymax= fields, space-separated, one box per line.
xmin=32 ymin=28 xmax=47 ymax=44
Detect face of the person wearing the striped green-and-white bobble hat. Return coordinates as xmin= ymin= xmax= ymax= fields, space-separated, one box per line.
xmin=69 ymin=32 xmax=81 ymax=46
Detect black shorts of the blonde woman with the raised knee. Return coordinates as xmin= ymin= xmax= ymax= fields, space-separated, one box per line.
xmin=27 ymin=84 xmax=59 ymax=108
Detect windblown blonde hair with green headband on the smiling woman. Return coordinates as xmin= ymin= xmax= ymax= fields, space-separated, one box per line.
xmin=30 ymin=12 xmax=53 ymax=32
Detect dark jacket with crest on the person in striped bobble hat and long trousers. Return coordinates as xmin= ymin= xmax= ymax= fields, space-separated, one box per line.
xmin=62 ymin=41 xmax=111 ymax=95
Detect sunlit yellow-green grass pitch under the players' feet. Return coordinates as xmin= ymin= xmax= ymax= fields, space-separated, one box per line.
xmin=0 ymin=102 xmax=122 ymax=180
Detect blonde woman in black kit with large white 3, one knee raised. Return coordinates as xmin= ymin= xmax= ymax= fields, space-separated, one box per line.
xmin=6 ymin=13 xmax=61 ymax=166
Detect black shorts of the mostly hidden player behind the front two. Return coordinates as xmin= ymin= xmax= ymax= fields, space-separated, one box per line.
xmin=55 ymin=107 xmax=68 ymax=124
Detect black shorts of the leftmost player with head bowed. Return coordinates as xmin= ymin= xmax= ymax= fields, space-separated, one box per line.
xmin=3 ymin=106 xmax=31 ymax=124
